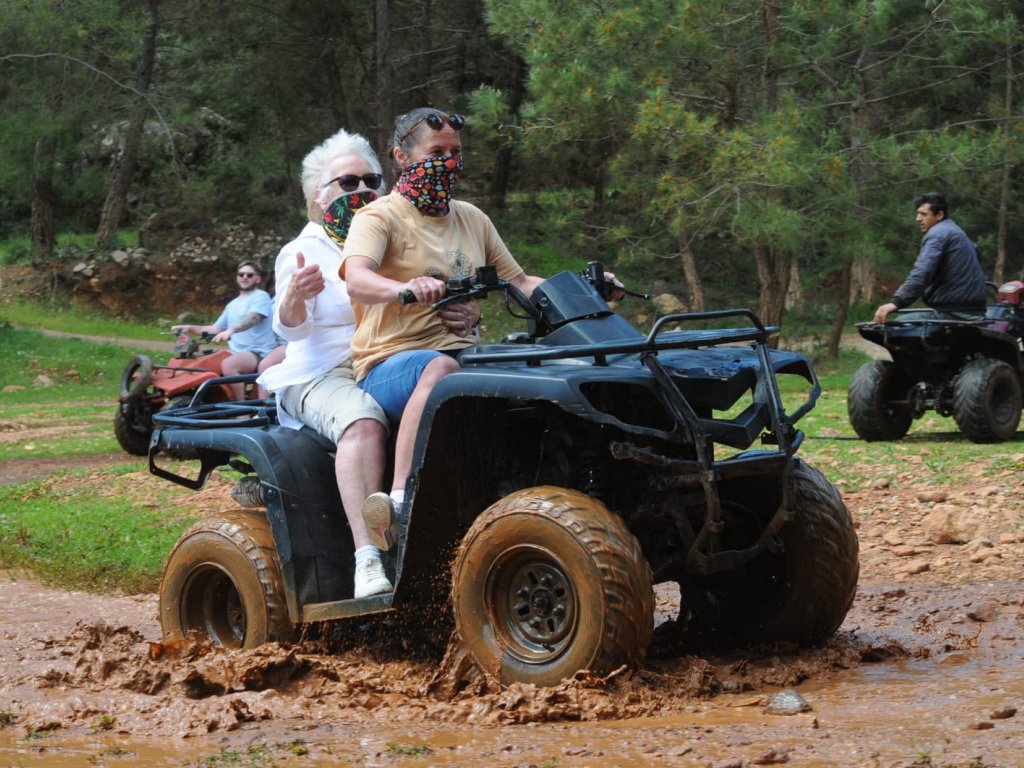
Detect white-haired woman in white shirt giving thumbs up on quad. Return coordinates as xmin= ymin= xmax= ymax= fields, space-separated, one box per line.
xmin=259 ymin=130 xmax=478 ymax=598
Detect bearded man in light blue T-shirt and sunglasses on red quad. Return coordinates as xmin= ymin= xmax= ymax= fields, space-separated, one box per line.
xmin=171 ymin=261 xmax=278 ymax=400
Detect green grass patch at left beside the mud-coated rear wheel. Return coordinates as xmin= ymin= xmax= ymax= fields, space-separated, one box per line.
xmin=0 ymin=466 xmax=201 ymax=594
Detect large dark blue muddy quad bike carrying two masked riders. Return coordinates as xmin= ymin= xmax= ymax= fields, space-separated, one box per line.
xmin=150 ymin=264 xmax=859 ymax=685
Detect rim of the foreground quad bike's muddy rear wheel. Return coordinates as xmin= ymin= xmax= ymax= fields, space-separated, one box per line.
xmin=181 ymin=563 xmax=247 ymax=648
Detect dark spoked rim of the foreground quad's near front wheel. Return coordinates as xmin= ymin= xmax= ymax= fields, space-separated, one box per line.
xmin=486 ymin=547 xmax=578 ymax=664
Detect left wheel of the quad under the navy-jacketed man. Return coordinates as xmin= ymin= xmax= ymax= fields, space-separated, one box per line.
xmin=846 ymin=360 xmax=913 ymax=440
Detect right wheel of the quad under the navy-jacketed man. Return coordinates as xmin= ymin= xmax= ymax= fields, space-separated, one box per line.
xmin=953 ymin=357 xmax=1021 ymax=442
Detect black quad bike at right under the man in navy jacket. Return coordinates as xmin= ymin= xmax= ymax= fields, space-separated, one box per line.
xmin=847 ymin=281 xmax=1024 ymax=442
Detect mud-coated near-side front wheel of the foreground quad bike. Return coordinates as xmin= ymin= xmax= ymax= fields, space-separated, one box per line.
xmin=452 ymin=486 xmax=654 ymax=686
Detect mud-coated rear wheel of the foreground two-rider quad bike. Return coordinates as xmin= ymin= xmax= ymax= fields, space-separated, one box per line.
xmin=160 ymin=511 xmax=292 ymax=648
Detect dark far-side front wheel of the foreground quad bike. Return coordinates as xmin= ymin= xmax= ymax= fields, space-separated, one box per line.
xmin=680 ymin=459 xmax=860 ymax=646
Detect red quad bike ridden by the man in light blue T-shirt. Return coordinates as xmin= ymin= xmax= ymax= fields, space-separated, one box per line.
xmin=114 ymin=333 xmax=240 ymax=456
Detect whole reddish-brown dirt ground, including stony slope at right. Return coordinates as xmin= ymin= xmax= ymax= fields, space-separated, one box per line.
xmin=0 ymin=438 xmax=1024 ymax=768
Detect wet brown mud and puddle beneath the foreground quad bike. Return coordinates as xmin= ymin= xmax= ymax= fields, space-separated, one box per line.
xmin=0 ymin=582 xmax=1024 ymax=768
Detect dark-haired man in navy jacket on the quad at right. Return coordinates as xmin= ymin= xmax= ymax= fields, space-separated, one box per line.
xmin=874 ymin=193 xmax=987 ymax=323
